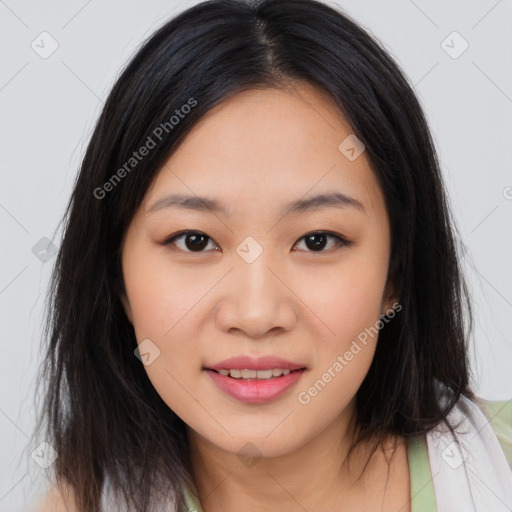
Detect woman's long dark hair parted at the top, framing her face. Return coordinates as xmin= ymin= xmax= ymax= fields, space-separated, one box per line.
xmin=34 ymin=0 xmax=473 ymax=512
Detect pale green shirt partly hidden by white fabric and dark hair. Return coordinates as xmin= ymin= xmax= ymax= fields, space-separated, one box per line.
xmin=184 ymin=399 xmax=512 ymax=512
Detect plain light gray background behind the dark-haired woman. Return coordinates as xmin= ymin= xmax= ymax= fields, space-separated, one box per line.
xmin=0 ymin=0 xmax=512 ymax=511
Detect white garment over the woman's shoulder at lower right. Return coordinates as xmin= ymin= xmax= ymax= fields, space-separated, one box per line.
xmin=427 ymin=397 xmax=512 ymax=512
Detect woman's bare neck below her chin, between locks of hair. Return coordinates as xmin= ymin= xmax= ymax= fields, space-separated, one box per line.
xmin=188 ymin=401 xmax=382 ymax=512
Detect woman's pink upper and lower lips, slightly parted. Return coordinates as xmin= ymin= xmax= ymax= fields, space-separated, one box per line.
xmin=203 ymin=356 xmax=306 ymax=404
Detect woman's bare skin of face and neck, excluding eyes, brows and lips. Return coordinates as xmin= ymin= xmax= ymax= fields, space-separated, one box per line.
xmin=122 ymin=83 xmax=410 ymax=512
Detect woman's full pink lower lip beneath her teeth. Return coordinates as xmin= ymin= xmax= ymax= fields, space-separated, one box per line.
xmin=206 ymin=370 xmax=305 ymax=404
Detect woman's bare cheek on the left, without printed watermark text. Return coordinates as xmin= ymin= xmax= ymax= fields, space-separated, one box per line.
xmin=123 ymin=244 xmax=208 ymax=416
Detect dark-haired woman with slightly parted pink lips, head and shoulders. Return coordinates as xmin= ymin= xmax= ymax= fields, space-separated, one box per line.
xmin=33 ymin=0 xmax=512 ymax=512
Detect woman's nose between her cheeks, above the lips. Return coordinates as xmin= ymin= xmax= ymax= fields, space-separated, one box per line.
xmin=216 ymin=252 xmax=298 ymax=339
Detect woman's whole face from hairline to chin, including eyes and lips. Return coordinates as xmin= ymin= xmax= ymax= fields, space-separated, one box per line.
xmin=122 ymin=84 xmax=394 ymax=457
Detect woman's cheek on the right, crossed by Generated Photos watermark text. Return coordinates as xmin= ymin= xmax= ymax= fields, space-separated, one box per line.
xmin=302 ymin=240 xmax=388 ymax=396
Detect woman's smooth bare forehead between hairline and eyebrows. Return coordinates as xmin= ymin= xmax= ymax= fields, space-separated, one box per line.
xmin=140 ymin=83 xmax=382 ymax=221
